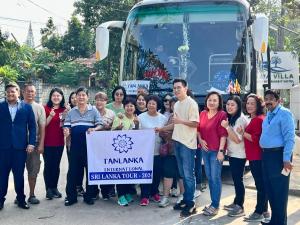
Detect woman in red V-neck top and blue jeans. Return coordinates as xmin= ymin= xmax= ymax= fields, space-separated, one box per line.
xmin=198 ymin=92 xmax=227 ymax=216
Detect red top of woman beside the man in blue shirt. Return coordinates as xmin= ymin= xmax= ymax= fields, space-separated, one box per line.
xmin=244 ymin=115 xmax=265 ymax=160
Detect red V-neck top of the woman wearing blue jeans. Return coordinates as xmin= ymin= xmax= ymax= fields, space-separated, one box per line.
xmin=198 ymin=110 xmax=227 ymax=151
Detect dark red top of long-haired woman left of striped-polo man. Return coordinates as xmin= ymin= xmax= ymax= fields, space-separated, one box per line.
xmin=44 ymin=105 xmax=65 ymax=147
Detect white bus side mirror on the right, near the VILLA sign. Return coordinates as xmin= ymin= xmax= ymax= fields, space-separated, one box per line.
xmin=252 ymin=13 xmax=269 ymax=53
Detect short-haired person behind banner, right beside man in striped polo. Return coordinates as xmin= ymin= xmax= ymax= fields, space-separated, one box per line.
xmin=95 ymin=92 xmax=115 ymax=200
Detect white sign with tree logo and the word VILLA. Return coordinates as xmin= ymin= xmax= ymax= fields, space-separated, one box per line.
xmin=264 ymin=52 xmax=299 ymax=89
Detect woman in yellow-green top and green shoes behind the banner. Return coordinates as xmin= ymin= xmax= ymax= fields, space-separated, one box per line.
xmin=112 ymin=98 xmax=139 ymax=206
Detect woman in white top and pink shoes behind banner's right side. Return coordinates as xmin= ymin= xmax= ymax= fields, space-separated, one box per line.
xmin=139 ymin=95 xmax=168 ymax=206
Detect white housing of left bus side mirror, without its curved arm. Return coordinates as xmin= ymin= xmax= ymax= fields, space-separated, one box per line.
xmin=96 ymin=26 xmax=109 ymax=61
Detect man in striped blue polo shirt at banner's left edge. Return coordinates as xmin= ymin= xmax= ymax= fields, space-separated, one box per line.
xmin=64 ymin=87 xmax=102 ymax=206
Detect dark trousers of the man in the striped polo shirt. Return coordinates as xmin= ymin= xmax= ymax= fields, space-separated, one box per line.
xmin=66 ymin=146 xmax=98 ymax=201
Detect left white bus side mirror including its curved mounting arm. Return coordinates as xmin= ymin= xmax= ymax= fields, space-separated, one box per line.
xmin=96 ymin=21 xmax=125 ymax=60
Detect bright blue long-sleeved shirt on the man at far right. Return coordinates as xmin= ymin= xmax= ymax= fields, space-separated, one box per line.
xmin=259 ymin=105 xmax=295 ymax=162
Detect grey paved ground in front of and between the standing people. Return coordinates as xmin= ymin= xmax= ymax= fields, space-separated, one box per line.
xmin=0 ymin=140 xmax=300 ymax=225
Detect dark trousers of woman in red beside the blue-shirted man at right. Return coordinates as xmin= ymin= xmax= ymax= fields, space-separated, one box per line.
xmin=249 ymin=160 xmax=268 ymax=214
